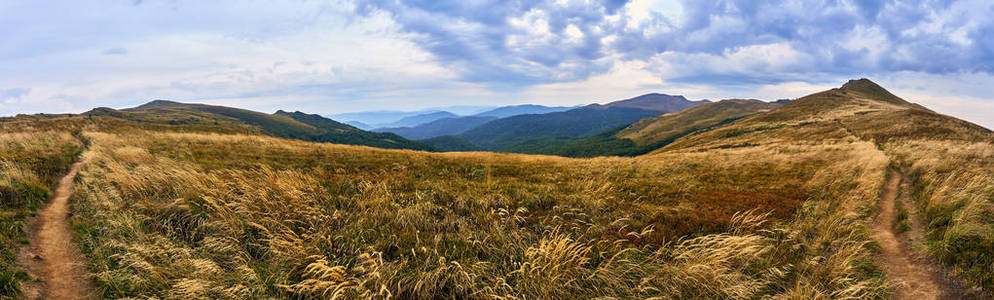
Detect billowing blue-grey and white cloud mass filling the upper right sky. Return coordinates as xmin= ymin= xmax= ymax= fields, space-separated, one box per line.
xmin=359 ymin=0 xmax=994 ymax=85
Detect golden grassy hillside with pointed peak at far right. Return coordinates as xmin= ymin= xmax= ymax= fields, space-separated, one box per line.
xmin=656 ymin=79 xmax=994 ymax=291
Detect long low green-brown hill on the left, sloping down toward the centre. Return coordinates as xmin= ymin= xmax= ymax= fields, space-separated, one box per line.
xmin=99 ymin=100 xmax=434 ymax=150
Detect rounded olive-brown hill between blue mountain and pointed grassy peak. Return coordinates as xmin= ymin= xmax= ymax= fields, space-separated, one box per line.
xmin=547 ymin=99 xmax=782 ymax=157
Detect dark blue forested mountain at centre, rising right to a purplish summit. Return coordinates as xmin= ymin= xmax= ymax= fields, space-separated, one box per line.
xmin=458 ymin=94 xmax=708 ymax=154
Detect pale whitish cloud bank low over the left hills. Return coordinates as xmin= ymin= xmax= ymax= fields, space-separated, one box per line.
xmin=0 ymin=1 xmax=455 ymax=114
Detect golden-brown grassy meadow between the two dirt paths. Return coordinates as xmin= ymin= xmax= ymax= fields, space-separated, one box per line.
xmin=72 ymin=130 xmax=888 ymax=299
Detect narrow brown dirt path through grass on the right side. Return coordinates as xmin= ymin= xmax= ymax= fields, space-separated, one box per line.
xmin=873 ymin=170 xmax=962 ymax=299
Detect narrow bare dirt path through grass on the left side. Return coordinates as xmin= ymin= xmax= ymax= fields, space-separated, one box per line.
xmin=17 ymin=162 xmax=96 ymax=299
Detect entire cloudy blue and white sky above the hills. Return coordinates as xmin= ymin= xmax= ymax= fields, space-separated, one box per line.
xmin=0 ymin=0 xmax=994 ymax=128
